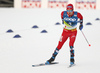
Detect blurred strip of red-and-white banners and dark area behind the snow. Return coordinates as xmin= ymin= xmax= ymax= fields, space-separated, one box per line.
xmin=0 ymin=0 xmax=100 ymax=9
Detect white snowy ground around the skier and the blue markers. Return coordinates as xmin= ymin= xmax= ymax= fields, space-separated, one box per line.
xmin=0 ymin=8 xmax=100 ymax=73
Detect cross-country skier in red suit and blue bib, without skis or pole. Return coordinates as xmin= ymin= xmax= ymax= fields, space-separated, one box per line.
xmin=45 ymin=4 xmax=83 ymax=65
